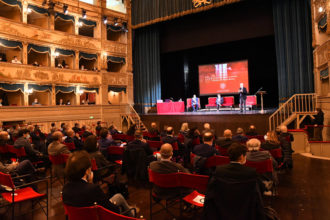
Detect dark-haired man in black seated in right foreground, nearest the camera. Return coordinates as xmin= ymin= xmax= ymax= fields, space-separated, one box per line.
xmin=203 ymin=143 xmax=265 ymax=220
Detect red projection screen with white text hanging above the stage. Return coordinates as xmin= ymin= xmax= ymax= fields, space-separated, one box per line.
xmin=198 ymin=60 xmax=249 ymax=95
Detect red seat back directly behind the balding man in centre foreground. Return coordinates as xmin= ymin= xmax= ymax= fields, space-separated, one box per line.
xmin=148 ymin=169 xmax=180 ymax=188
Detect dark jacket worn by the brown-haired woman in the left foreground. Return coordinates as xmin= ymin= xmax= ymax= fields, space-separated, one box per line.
xmin=63 ymin=180 xmax=120 ymax=213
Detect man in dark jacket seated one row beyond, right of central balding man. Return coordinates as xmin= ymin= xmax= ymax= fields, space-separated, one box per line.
xmin=193 ymin=131 xmax=218 ymax=158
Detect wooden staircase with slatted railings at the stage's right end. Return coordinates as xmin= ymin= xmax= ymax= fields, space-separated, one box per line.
xmin=269 ymin=93 xmax=316 ymax=130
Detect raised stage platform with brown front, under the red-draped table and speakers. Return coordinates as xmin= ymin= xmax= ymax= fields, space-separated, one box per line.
xmin=140 ymin=108 xmax=276 ymax=136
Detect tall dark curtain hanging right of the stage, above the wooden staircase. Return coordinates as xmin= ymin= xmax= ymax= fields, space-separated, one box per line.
xmin=273 ymin=0 xmax=314 ymax=102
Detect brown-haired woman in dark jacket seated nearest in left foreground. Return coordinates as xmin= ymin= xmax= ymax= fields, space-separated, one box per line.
xmin=62 ymin=151 xmax=135 ymax=217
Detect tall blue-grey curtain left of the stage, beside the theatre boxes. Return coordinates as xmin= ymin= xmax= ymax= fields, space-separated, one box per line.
xmin=133 ymin=25 xmax=161 ymax=113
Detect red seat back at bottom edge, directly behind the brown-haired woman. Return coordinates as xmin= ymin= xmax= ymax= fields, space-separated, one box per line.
xmin=63 ymin=204 xmax=99 ymax=220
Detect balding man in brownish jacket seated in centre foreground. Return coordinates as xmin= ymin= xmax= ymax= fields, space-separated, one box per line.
xmin=150 ymin=144 xmax=191 ymax=199
